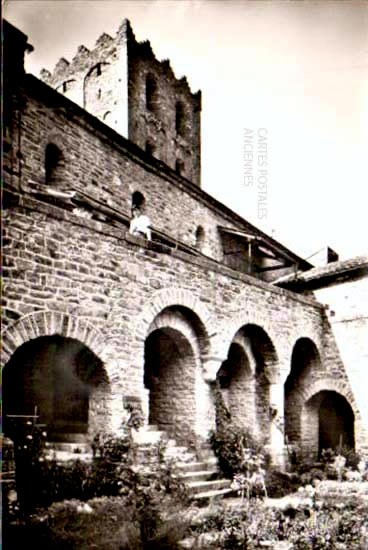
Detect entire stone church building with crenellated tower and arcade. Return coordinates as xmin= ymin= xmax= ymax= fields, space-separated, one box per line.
xmin=2 ymin=20 xmax=368 ymax=465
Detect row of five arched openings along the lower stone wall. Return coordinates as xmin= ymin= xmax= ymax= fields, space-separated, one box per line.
xmin=3 ymin=314 xmax=355 ymax=458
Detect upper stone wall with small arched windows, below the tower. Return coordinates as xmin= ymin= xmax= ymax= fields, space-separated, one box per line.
xmin=4 ymin=77 xmax=264 ymax=266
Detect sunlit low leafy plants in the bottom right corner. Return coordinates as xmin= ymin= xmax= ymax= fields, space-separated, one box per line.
xmin=192 ymin=481 xmax=368 ymax=550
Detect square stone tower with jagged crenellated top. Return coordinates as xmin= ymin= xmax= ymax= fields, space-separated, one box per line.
xmin=40 ymin=19 xmax=201 ymax=185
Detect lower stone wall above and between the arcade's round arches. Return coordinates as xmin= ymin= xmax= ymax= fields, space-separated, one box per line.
xmin=3 ymin=192 xmax=356 ymax=460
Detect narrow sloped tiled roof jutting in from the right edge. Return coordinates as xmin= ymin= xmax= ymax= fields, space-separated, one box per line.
xmin=273 ymin=255 xmax=368 ymax=288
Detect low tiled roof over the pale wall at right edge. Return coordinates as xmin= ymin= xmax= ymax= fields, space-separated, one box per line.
xmin=273 ymin=256 xmax=368 ymax=286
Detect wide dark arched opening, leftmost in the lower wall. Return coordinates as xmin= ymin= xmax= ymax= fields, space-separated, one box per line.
xmin=3 ymin=335 xmax=108 ymax=439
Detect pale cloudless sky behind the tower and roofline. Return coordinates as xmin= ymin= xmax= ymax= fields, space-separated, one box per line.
xmin=3 ymin=0 xmax=368 ymax=263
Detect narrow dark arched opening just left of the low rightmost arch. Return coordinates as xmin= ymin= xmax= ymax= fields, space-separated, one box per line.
xmin=284 ymin=338 xmax=322 ymax=444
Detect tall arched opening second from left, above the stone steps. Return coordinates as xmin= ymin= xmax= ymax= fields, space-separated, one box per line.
xmin=144 ymin=306 xmax=208 ymax=445
